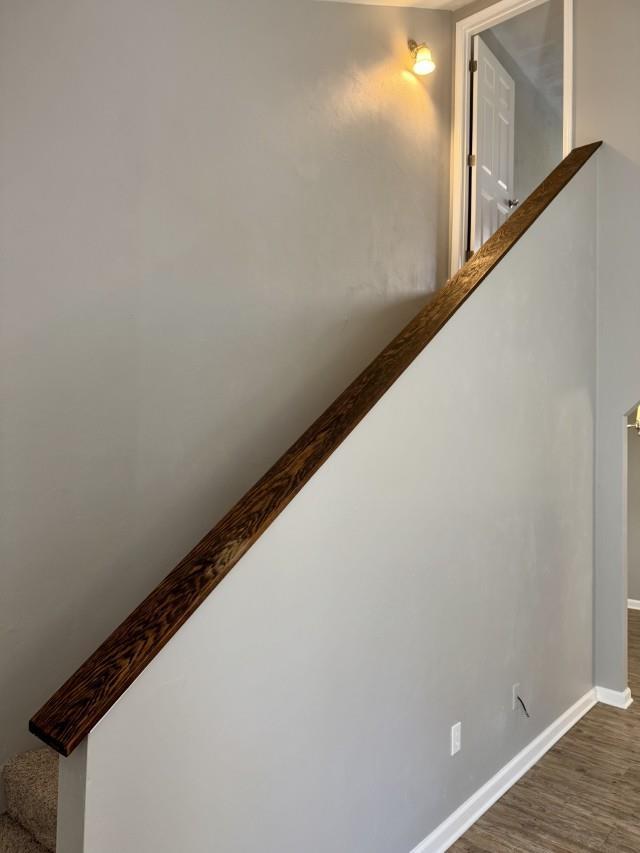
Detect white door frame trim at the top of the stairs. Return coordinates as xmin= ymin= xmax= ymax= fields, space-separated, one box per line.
xmin=450 ymin=0 xmax=573 ymax=275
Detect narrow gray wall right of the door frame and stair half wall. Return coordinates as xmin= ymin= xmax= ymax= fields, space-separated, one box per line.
xmin=575 ymin=0 xmax=640 ymax=690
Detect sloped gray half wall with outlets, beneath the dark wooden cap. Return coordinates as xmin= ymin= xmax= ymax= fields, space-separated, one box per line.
xmin=60 ymin=160 xmax=597 ymax=853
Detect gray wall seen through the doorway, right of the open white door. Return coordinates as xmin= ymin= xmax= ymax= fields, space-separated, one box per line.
xmin=482 ymin=23 xmax=562 ymax=201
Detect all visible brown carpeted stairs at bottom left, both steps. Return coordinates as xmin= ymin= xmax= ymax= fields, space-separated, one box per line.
xmin=0 ymin=749 xmax=58 ymax=853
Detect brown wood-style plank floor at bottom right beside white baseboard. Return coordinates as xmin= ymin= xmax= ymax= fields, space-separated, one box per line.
xmin=450 ymin=610 xmax=640 ymax=853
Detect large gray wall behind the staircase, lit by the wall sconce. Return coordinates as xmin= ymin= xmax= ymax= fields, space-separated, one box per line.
xmin=0 ymin=0 xmax=451 ymax=784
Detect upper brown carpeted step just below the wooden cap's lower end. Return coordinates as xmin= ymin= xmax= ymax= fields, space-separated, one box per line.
xmin=0 ymin=748 xmax=58 ymax=853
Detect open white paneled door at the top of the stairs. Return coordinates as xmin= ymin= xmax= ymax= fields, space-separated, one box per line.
xmin=469 ymin=36 xmax=518 ymax=252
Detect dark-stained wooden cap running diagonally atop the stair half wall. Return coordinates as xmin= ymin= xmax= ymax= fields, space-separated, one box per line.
xmin=29 ymin=142 xmax=601 ymax=755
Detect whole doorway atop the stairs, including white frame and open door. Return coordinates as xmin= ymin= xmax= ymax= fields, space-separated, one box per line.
xmin=451 ymin=0 xmax=573 ymax=274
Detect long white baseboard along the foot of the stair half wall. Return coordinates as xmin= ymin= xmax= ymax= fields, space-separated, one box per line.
xmin=411 ymin=688 xmax=597 ymax=853
